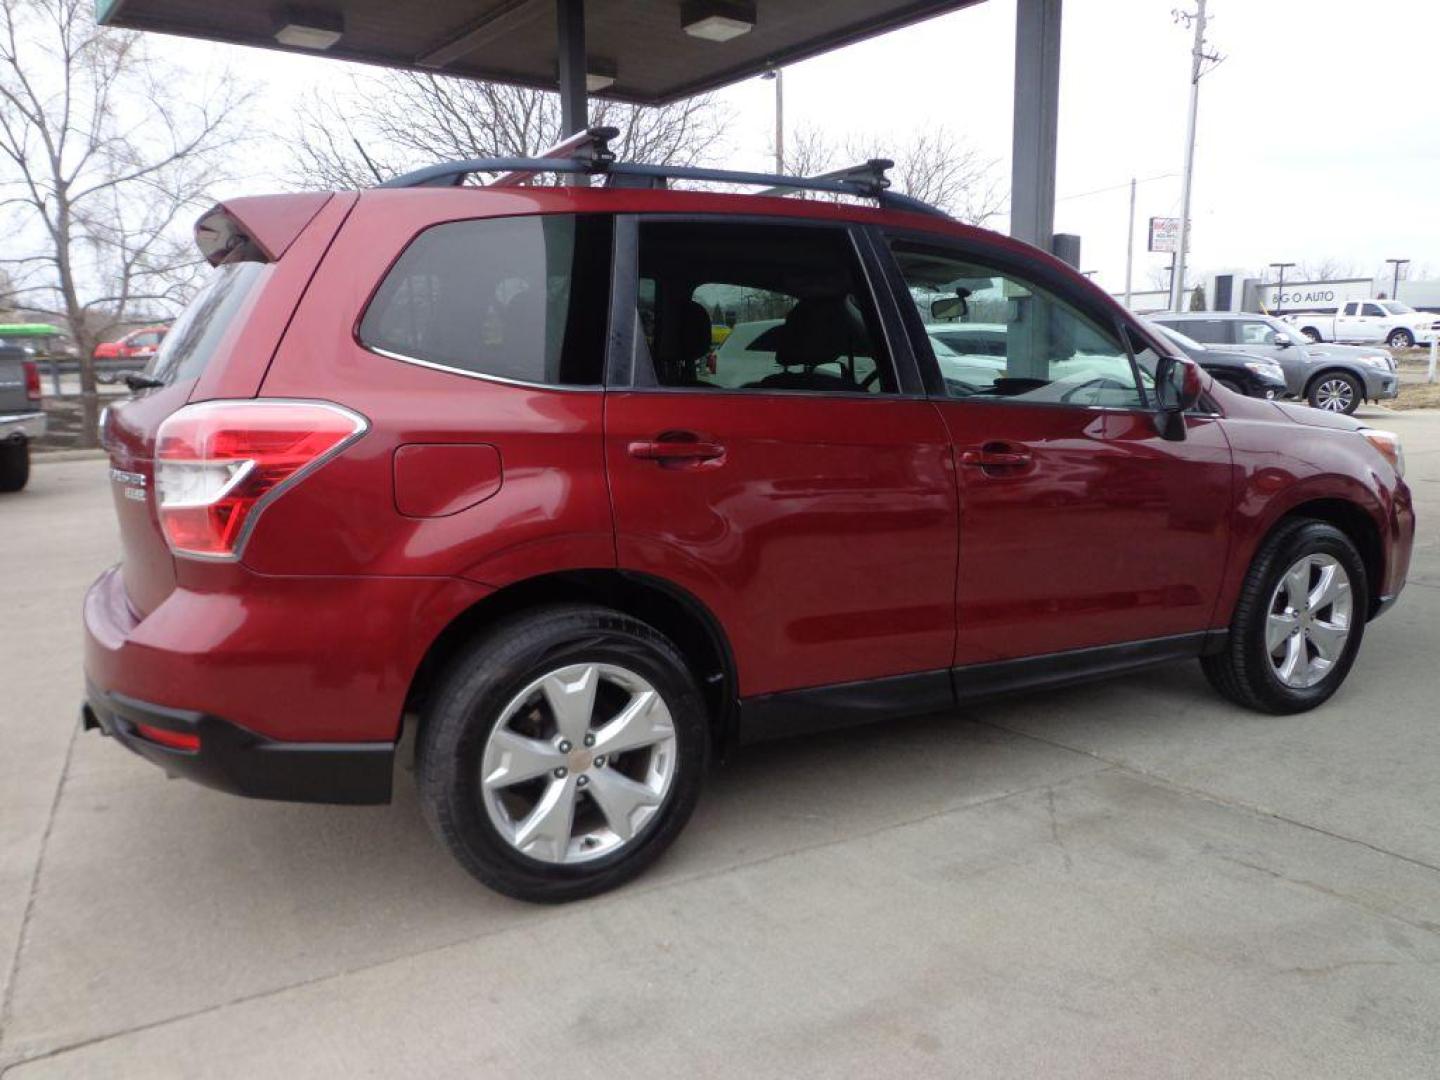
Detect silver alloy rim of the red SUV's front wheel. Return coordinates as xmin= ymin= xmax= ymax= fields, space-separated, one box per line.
xmin=1266 ymin=554 xmax=1355 ymax=688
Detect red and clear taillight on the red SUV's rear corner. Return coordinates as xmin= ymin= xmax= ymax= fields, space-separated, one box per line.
xmin=156 ymin=399 xmax=369 ymax=559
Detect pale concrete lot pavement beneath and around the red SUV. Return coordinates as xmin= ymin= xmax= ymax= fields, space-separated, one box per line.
xmin=0 ymin=409 xmax=1440 ymax=1080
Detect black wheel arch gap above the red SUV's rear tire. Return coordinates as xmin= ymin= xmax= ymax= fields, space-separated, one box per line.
xmin=405 ymin=569 xmax=739 ymax=753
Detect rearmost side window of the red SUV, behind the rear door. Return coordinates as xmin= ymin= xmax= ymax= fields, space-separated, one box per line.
xmin=360 ymin=215 xmax=611 ymax=386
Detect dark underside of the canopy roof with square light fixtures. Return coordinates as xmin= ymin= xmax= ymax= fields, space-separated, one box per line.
xmin=95 ymin=0 xmax=981 ymax=104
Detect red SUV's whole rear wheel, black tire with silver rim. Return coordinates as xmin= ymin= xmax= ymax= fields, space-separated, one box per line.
xmin=416 ymin=606 xmax=710 ymax=903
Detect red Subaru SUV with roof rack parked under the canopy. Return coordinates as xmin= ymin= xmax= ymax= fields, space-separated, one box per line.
xmin=84 ymin=141 xmax=1414 ymax=900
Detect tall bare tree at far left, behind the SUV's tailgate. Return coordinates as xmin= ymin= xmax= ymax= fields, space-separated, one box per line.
xmin=0 ymin=0 xmax=249 ymax=445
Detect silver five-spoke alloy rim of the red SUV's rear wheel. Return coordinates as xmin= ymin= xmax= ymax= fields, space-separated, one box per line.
xmin=480 ymin=664 xmax=677 ymax=864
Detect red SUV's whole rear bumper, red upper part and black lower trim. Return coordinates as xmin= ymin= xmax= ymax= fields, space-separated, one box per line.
xmin=84 ymin=564 xmax=488 ymax=802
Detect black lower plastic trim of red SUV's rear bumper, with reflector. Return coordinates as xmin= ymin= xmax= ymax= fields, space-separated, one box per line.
xmin=81 ymin=684 xmax=395 ymax=805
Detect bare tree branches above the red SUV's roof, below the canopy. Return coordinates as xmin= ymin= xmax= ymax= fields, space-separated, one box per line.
xmin=289 ymin=72 xmax=727 ymax=189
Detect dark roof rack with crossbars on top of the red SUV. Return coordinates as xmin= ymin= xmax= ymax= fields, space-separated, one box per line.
xmin=377 ymin=127 xmax=949 ymax=217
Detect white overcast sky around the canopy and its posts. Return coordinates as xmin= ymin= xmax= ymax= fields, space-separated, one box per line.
xmin=156 ymin=0 xmax=1440 ymax=291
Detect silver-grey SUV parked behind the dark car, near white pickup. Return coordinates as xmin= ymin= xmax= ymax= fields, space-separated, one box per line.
xmin=1151 ymin=311 xmax=1400 ymax=413
